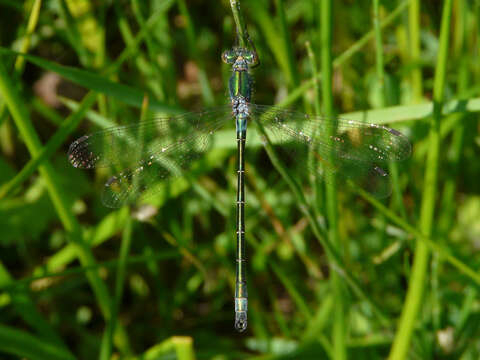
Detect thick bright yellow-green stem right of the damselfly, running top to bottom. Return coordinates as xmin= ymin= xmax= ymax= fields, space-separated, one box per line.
xmin=389 ymin=0 xmax=453 ymax=360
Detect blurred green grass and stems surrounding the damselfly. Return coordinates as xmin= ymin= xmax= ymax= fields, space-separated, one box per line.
xmin=0 ymin=0 xmax=480 ymax=360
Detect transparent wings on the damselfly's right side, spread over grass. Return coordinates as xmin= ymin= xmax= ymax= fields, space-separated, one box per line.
xmin=250 ymin=105 xmax=411 ymax=198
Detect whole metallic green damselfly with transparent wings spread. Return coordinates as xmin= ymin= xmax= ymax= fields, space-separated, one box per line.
xmin=68 ymin=40 xmax=411 ymax=331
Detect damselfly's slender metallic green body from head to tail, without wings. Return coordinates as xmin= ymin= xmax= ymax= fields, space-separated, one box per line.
xmin=222 ymin=48 xmax=258 ymax=331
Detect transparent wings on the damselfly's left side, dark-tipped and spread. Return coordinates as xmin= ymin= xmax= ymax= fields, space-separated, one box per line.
xmin=68 ymin=105 xmax=232 ymax=208
